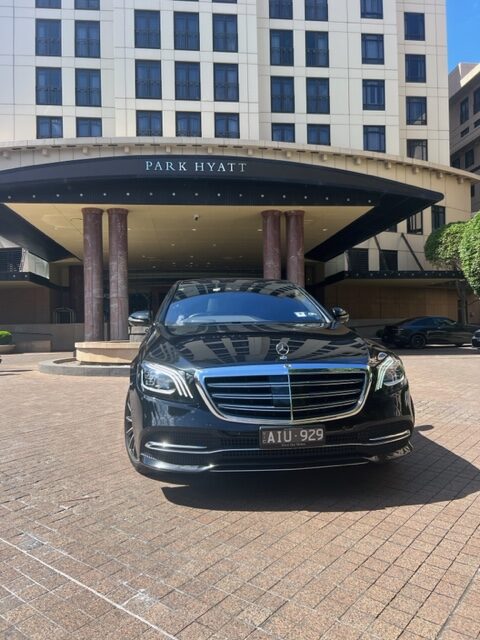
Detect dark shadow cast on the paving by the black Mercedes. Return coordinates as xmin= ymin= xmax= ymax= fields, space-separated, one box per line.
xmin=162 ymin=425 xmax=480 ymax=512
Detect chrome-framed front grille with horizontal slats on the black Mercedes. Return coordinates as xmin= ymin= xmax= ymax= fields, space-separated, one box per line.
xmin=199 ymin=365 xmax=368 ymax=424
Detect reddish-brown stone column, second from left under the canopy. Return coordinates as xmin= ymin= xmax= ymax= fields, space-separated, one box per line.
xmin=108 ymin=209 xmax=128 ymax=340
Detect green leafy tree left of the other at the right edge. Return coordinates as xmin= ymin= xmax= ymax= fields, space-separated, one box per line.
xmin=424 ymin=222 xmax=467 ymax=323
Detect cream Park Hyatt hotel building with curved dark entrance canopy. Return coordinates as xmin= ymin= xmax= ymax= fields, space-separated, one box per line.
xmin=0 ymin=0 xmax=476 ymax=348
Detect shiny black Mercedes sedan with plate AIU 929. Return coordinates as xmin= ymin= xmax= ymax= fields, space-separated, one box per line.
xmin=125 ymin=278 xmax=414 ymax=475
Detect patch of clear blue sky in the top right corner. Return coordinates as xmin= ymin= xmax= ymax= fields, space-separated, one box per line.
xmin=447 ymin=0 xmax=480 ymax=71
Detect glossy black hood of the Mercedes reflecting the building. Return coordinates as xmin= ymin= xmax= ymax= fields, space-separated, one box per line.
xmin=140 ymin=322 xmax=378 ymax=369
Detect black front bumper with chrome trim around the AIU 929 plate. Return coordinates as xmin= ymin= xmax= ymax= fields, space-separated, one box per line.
xmin=130 ymin=386 xmax=414 ymax=473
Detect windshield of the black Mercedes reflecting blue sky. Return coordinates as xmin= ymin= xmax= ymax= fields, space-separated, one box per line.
xmin=165 ymin=281 xmax=331 ymax=326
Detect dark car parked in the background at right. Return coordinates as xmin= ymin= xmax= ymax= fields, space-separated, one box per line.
xmin=381 ymin=316 xmax=480 ymax=349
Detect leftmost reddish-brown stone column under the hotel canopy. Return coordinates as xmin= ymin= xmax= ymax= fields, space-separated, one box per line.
xmin=82 ymin=207 xmax=103 ymax=342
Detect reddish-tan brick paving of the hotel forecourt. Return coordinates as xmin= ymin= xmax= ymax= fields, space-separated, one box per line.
xmin=0 ymin=348 xmax=480 ymax=640
